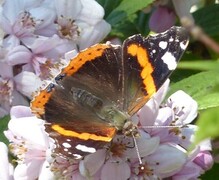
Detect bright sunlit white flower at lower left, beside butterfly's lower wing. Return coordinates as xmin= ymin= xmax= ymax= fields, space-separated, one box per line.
xmin=5 ymin=106 xmax=53 ymax=179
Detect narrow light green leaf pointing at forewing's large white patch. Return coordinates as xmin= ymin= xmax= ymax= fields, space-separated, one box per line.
xmin=178 ymin=60 xmax=219 ymax=71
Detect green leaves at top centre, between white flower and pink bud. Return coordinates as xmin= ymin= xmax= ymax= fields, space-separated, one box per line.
xmin=99 ymin=0 xmax=153 ymax=39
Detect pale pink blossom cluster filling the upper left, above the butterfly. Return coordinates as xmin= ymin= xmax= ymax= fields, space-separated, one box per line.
xmin=0 ymin=0 xmax=111 ymax=117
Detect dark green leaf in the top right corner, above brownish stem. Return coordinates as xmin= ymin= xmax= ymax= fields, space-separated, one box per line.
xmin=193 ymin=4 xmax=219 ymax=36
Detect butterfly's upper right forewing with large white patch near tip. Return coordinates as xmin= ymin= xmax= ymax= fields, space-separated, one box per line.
xmin=123 ymin=27 xmax=188 ymax=115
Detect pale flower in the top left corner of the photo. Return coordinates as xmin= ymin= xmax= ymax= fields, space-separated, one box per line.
xmin=0 ymin=0 xmax=55 ymax=44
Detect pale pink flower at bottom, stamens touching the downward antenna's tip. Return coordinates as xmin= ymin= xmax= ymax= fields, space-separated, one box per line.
xmin=131 ymin=144 xmax=186 ymax=179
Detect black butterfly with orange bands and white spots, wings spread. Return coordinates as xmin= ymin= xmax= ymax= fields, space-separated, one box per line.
xmin=31 ymin=27 xmax=189 ymax=159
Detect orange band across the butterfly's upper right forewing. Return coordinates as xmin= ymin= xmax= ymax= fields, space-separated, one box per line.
xmin=128 ymin=44 xmax=157 ymax=96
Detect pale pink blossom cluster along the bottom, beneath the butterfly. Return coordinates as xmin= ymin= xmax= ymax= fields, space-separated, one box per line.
xmin=0 ymin=81 xmax=213 ymax=180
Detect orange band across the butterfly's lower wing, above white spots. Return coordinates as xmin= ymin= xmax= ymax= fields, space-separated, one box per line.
xmin=52 ymin=124 xmax=116 ymax=142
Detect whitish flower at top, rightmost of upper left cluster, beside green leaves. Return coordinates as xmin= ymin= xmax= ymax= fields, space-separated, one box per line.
xmin=55 ymin=0 xmax=111 ymax=50
